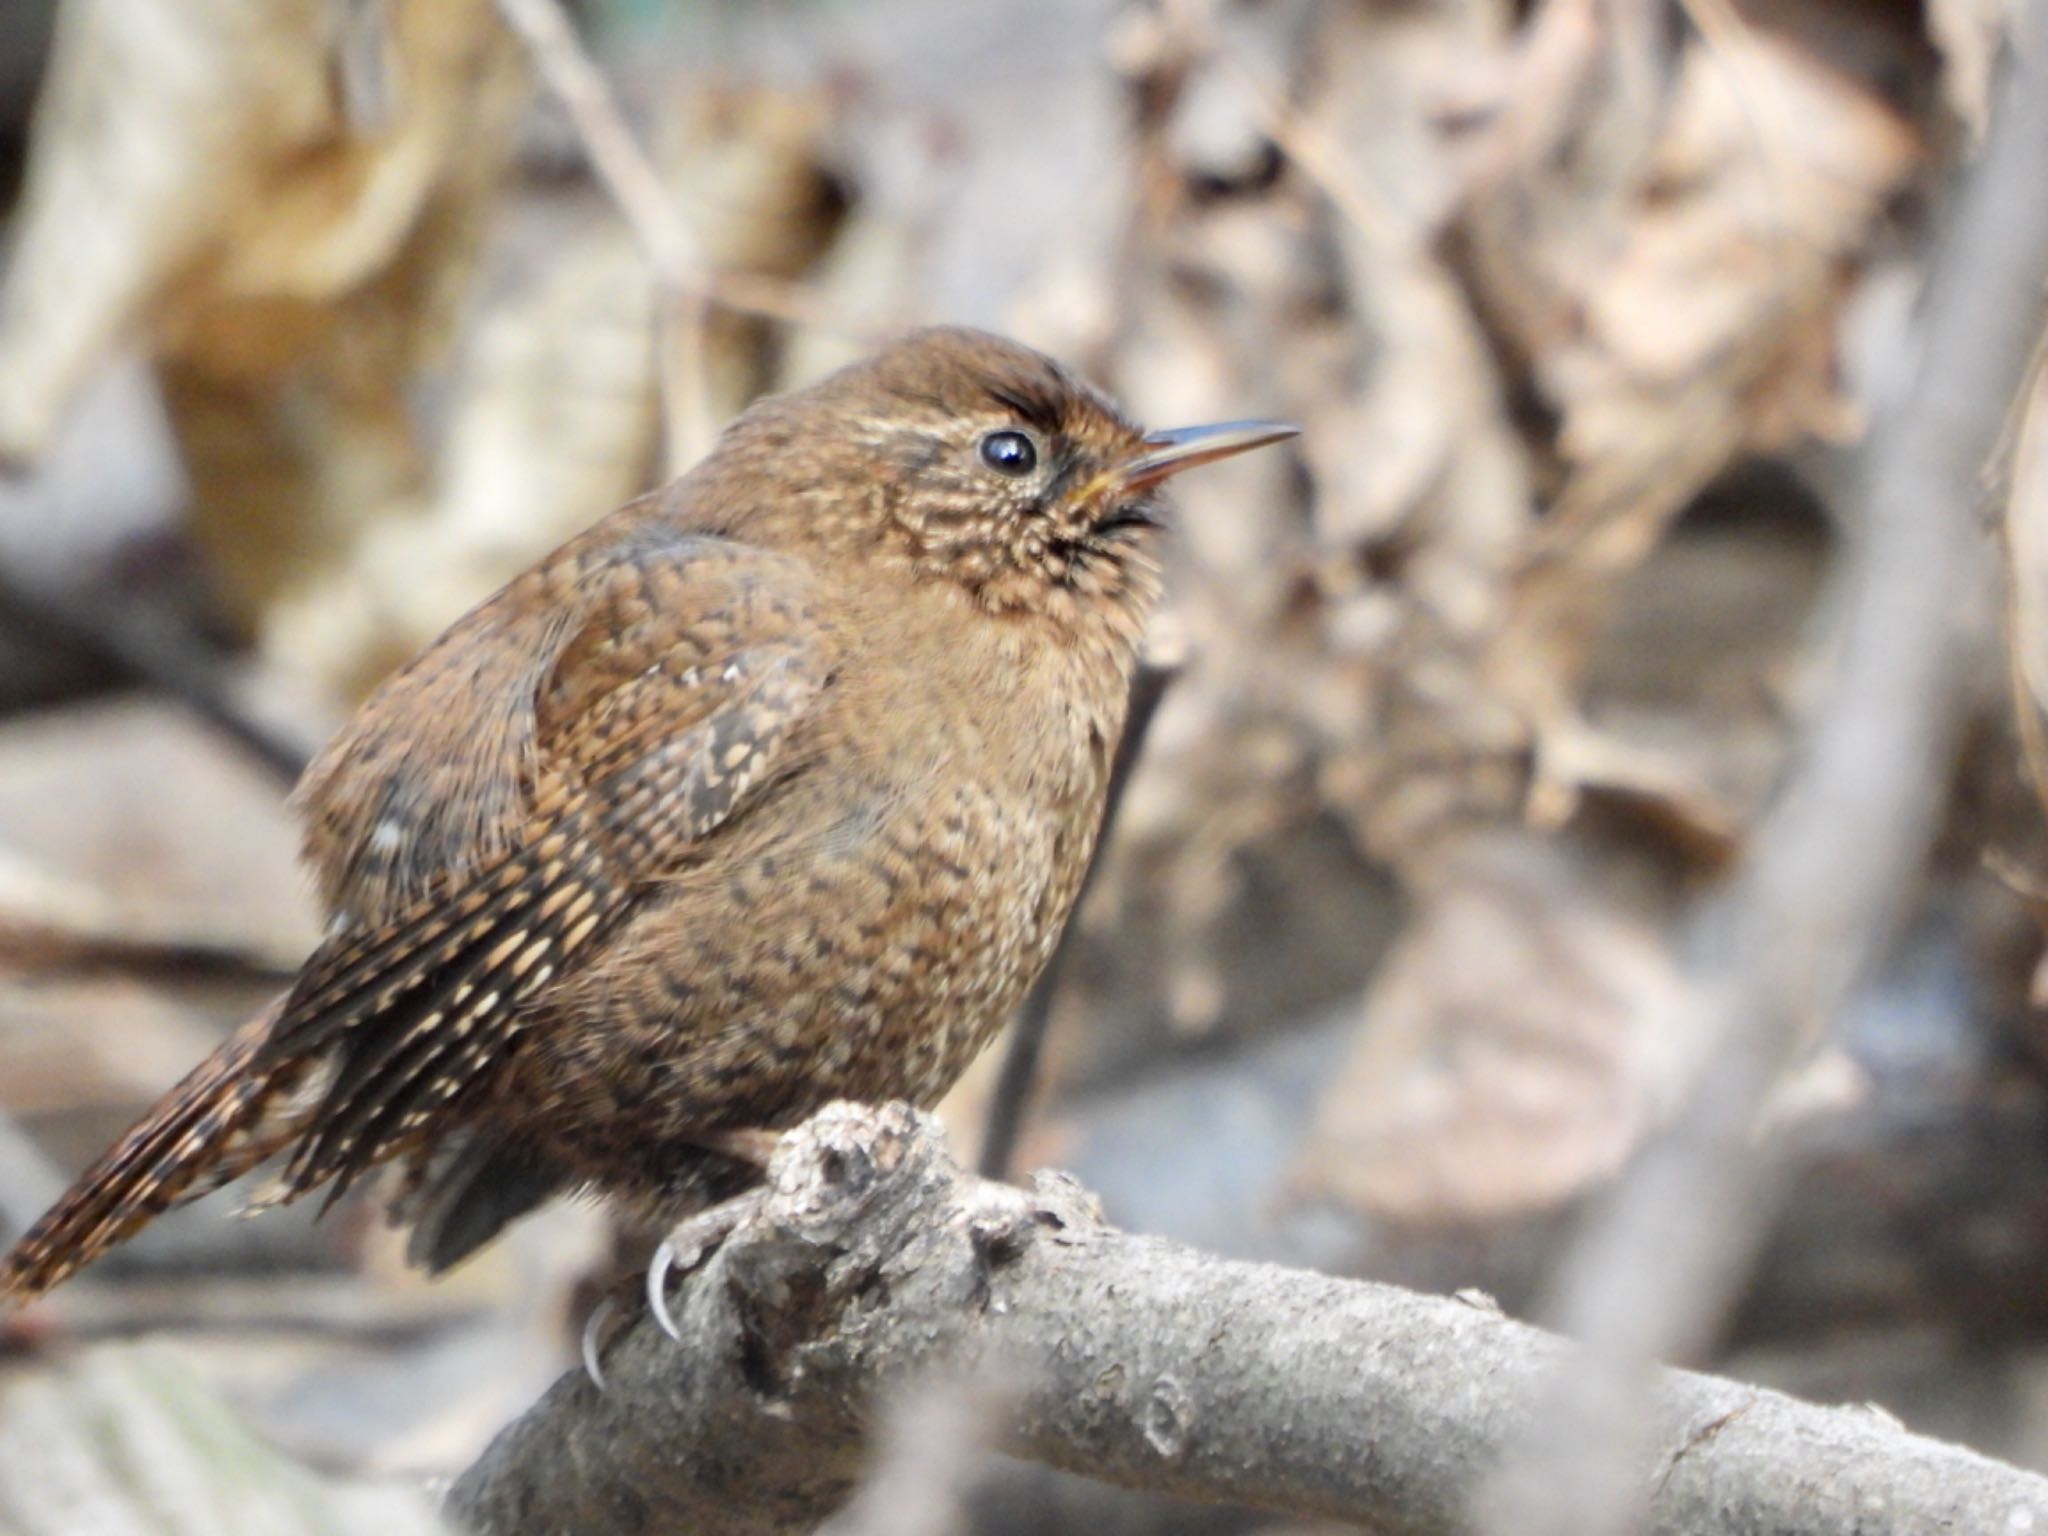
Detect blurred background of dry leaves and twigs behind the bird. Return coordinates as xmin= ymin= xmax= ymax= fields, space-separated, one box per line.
xmin=0 ymin=0 xmax=2048 ymax=1536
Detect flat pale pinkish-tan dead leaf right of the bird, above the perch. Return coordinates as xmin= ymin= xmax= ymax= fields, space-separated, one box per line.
xmin=1296 ymin=844 xmax=1694 ymax=1223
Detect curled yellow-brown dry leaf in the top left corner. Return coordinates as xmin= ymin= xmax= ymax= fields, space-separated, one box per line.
xmin=0 ymin=0 xmax=526 ymax=625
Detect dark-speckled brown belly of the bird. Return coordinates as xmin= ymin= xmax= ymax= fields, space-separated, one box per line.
xmin=503 ymin=765 xmax=1096 ymax=1182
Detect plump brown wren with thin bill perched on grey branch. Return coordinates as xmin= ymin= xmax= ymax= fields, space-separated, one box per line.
xmin=0 ymin=326 xmax=1296 ymax=1305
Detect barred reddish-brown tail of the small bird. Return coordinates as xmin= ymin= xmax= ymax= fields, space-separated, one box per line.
xmin=0 ymin=1006 xmax=309 ymax=1309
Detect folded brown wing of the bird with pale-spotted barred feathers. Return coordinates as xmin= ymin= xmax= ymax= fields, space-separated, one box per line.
xmin=268 ymin=530 xmax=831 ymax=1200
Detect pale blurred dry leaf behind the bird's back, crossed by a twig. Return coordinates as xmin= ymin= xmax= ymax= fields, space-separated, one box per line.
xmin=264 ymin=84 xmax=838 ymax=696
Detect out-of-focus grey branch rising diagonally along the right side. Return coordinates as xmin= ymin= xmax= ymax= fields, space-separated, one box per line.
xmin=1481 ymin=0 xmax=2048 ymax=1536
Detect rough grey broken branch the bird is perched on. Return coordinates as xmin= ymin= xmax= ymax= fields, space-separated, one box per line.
xmin=451 ymin=1106 xmax=2048 ymax=1536
